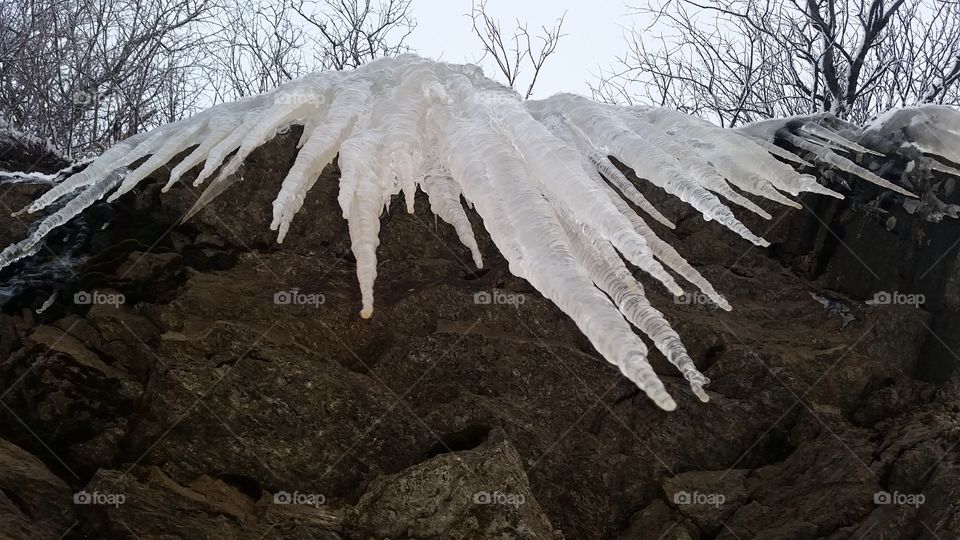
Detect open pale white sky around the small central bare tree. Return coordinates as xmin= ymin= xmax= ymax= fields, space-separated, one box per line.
xmin=407 ymin=0 xmax=633 ymax=98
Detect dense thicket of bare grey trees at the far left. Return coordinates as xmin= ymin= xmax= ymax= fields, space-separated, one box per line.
xmin=0 ymin=0 xmax=213 ymax=152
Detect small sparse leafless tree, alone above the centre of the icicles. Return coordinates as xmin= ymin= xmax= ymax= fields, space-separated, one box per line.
xmin=470 ymin=0 xmax=566 ymax=99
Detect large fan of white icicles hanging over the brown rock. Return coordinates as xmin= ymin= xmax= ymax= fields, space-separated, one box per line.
xmin=0 ymin=55 xmax=956 ymax=410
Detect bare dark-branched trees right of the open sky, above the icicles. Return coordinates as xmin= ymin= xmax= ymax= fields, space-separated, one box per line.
xmin=593 ymin=0 xmax=960 ymax=125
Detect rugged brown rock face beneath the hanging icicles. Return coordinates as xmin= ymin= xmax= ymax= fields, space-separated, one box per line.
xmin=0 ymin=130 xmax=960 ymax=540
